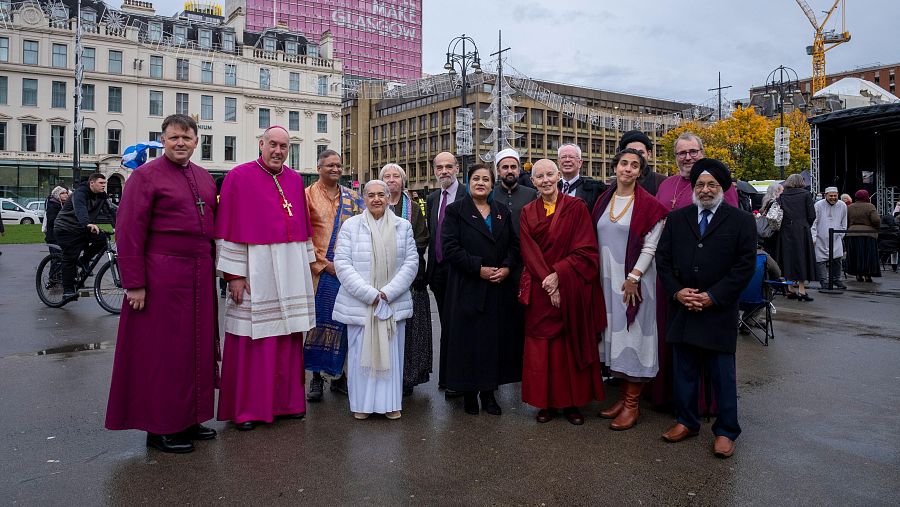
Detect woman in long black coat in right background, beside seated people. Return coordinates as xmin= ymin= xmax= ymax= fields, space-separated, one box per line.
xmin=775 ymin=174 xmax=816 ymax=301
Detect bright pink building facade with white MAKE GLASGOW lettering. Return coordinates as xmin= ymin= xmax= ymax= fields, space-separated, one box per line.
xmin=246 ymin=0 xmax=422 ymax=80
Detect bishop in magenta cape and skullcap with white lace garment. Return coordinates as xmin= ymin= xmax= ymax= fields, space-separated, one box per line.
xmin=215 ymin=127 xmax=316 ymax=430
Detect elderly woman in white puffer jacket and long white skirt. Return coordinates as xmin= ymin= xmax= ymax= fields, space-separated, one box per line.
xmin=332 ymin=180 xmax=419 ymax=419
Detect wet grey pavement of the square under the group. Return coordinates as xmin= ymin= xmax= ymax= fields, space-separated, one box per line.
xmin=0 ymin=245 xmax=900 ymax=505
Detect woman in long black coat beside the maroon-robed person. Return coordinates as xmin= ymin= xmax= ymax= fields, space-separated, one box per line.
xmin=441 ymin=165 xmax=523 ymax=415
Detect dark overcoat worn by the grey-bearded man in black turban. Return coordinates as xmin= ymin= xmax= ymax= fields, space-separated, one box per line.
xmin=656 ymin=202 xmax=756 ymax=354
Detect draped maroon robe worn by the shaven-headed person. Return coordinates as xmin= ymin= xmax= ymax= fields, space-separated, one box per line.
xmin=519 ymin=194 xmax=606 ymax=408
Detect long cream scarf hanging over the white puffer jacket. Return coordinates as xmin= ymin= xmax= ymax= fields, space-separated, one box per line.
xmin=360 ymin=209 xmax=397 ymax=376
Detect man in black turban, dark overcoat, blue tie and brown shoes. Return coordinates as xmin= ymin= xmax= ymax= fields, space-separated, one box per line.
xmin=656 ymin=158 xmax=756 ymax=458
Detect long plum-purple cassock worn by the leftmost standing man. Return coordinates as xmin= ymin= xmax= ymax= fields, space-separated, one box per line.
xmin=106 ymin=156 xmax=217 ymax=434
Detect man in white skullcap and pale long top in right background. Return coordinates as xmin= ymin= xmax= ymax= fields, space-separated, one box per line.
xmin=812 ymin=187 xmax=847 ymax=289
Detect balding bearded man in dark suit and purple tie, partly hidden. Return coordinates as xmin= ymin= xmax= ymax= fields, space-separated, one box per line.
xmin=425 ymin=151 xmax=466 ymax=397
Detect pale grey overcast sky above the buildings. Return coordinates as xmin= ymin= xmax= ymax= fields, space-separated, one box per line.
xmin=144 ymin=0 xmax=900 ymax=103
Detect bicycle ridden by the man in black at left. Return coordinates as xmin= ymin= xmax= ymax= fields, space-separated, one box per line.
xmin=34 ymin=231 xmax=125 ymax=314
